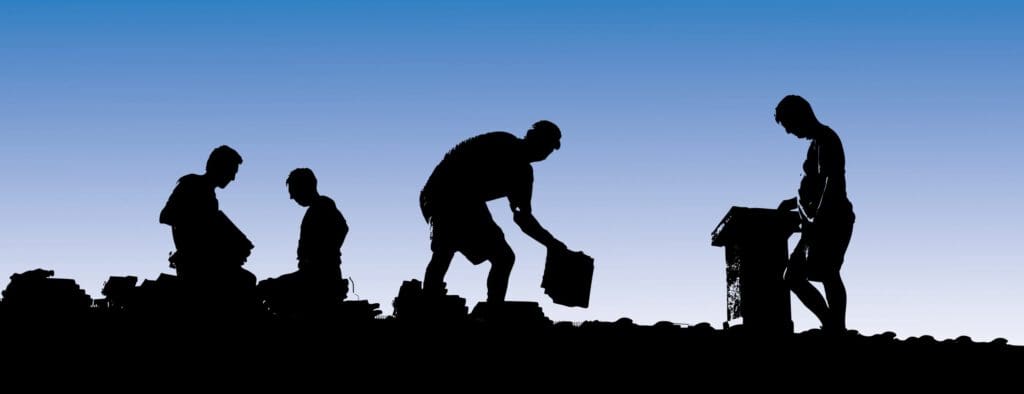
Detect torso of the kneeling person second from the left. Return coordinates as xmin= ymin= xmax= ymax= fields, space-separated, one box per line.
xmin=297 ymin=195 xmax=348 ymax=269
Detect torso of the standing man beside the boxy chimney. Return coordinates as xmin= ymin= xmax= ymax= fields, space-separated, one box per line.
xmin=799 ymin=127 xmax=853 ymax=221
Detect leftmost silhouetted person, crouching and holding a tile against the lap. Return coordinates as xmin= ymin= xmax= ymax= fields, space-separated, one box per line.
xmin=160 ymin=145 xmax=256 ymax=297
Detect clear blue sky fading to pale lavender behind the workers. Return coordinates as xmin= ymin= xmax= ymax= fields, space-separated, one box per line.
xmin=0 ymin=0 xmax=1024 ymax=344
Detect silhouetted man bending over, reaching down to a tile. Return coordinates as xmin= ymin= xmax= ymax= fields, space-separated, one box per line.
xmin=420 ymin=121 xmax=566 ymax=303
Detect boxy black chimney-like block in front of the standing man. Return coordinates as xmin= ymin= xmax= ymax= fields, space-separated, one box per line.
xmin=711 ymin=207 xmax=800 ymax=334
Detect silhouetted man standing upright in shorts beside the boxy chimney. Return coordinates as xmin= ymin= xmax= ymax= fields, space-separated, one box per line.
xmin=775 ymin=95 xmax=855 ymax=332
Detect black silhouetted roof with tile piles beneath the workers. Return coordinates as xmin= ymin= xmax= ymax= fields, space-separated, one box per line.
xmin=0 ymin=270 xmax=1024 ymax=384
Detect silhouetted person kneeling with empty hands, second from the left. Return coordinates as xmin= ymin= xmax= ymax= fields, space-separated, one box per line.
xmin=260 ymin=168 xmax=348 ymax=316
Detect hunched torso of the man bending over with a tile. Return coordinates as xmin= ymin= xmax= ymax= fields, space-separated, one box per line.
xmin=420 ymin=131 xmax=534 ymax=218
